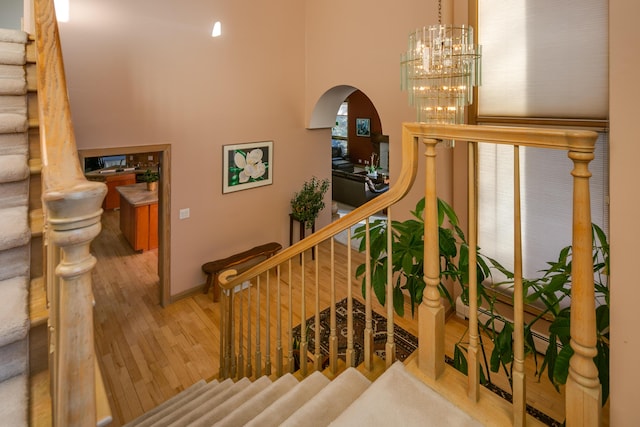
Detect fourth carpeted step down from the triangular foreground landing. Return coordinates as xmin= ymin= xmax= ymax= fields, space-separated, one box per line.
xmin=179 ymin=376 xmax=273 ymax=427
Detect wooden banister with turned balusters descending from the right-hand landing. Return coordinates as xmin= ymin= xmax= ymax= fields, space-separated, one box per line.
xmin=220 ymin=123 xmax=601 ymax=426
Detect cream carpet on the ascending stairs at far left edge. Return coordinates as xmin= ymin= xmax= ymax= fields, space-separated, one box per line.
xmin=0 ymin=29 xmax=31 ymax=426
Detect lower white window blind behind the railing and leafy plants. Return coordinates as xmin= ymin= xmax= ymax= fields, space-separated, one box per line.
xmin=478 ymin=133 xmax=609 ymax=278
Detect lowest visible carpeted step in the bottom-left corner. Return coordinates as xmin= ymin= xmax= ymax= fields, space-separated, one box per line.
xmin=0 ymin=373 xmax=29 ymax=427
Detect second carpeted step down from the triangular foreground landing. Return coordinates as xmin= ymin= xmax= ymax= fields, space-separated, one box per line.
xmin=245 ymin=371 xmax=330 ymax=427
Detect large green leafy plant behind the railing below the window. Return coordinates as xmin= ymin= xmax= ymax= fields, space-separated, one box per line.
xmin=354 ymin=199 xmax=609 ymax=410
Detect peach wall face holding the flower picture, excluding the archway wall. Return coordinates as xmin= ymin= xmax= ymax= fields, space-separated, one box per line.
xmin=60 ymin=0 xmax=320 ymax=295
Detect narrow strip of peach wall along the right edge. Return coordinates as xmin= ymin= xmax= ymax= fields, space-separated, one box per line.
xmin=609 ymin=0 xmax=640 ymax=426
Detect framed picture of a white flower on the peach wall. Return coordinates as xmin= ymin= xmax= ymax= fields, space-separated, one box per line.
xmin=222 ymin=141 xmax=273 ymax=194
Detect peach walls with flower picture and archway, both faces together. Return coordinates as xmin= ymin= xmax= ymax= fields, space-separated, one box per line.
xmin=60 ymin=0 xmax=450 ymax=295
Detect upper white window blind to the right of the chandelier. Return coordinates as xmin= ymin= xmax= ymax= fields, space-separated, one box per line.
xmin=477 ymin=0 xmax=609 ymax=119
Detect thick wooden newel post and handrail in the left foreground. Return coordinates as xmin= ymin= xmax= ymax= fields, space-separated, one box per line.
xmin=34 ymin=0 xmax=110 ymax=426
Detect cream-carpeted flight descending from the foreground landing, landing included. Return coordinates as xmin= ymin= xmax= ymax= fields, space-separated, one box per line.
xmin=121 ymin=362 xmax=482 ymax=427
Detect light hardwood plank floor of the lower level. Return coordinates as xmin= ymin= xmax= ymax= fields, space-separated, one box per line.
xmin=93 ymin=211 xmax=580 ymax=426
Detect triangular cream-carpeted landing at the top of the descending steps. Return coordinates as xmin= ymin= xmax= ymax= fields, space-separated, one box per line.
xmin=330 ymin=361 xmax=482 ymax=427
